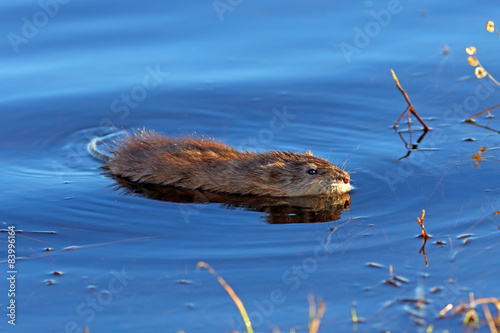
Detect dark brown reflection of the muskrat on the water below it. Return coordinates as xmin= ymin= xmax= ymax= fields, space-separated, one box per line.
xmin=113 ymin=177 xmax=351 ymax=224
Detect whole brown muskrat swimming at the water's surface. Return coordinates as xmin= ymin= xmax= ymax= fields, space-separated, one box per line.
xmin=89 ymin=130 xmax=351 ymax=197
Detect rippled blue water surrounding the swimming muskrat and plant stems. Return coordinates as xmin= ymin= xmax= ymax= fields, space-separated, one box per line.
xmin=0 ymin=0 xmax=500 ymax=333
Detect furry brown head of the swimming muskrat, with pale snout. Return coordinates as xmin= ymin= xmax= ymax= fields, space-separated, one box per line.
xmin=264 ymin=153 xmax=351 ymax=196
